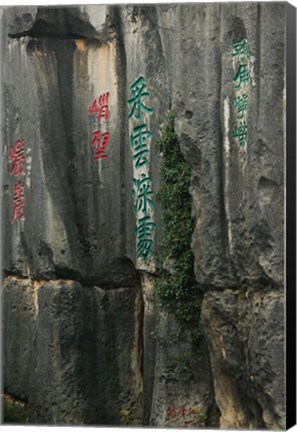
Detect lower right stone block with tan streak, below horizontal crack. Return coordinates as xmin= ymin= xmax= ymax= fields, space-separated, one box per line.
xmin=203 ymin=288 xmax=285 ymax=429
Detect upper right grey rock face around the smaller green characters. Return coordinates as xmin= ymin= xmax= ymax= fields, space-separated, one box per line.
xmin=160 ymin=3 xmax=285 ymax=288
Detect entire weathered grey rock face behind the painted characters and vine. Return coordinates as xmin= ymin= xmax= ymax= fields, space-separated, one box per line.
xmin=1 ymin=2 xmax=286 ymax=429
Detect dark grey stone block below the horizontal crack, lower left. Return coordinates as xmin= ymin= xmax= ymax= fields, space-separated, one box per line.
xmin=4 ymin=278 xmax=143 ymax=424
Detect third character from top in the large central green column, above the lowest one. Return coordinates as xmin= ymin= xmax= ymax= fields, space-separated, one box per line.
xmin=132 ymin=174 xmax=155 ymax=215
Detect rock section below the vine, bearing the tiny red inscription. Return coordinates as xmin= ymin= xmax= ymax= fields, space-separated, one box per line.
xmin=150 ymin=313 xmax=219 ymax=428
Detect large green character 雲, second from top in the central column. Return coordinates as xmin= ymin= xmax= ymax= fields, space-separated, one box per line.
xmin=130 ymin=125 xmax=153 ymax=168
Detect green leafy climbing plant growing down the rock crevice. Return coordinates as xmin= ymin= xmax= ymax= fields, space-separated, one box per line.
xmin=155 ymin=112 xmax=202 ymax=354
